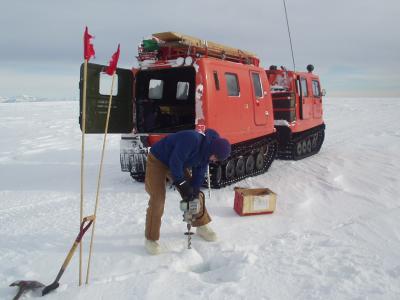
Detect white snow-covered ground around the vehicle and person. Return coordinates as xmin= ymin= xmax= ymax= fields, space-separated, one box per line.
xmin=0 ymin=98 xmax=400 ymax=300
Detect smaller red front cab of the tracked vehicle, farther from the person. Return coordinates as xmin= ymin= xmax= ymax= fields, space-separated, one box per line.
xmin=266 ymin=65 xmax=325 ymax=160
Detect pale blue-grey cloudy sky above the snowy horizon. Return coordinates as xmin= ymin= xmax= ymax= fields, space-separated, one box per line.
xmin=0 ymin=0 xmax=400 ymax=99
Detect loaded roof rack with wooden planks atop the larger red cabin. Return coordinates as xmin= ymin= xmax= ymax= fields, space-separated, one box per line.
xmin=137 ymin=32 xmax=260 ymax=66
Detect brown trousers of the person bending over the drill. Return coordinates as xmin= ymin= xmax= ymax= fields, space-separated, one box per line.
xmin=145 ymin=153 xmax=211 ymax=241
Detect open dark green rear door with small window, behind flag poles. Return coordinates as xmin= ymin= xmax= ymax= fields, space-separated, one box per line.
xmin=79 ymin=63 xmax=134 ymax=133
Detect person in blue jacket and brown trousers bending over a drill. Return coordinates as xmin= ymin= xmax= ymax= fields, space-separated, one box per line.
xmin=145 ymin=129 xmax=231 ymax=255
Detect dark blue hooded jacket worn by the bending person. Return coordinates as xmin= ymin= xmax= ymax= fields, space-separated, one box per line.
xmin=150 ymin=129 xmax=219 ymax=190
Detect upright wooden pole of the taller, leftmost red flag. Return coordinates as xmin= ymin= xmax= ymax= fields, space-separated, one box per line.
xmin=79 ymin=59 xmax=88 ymax=286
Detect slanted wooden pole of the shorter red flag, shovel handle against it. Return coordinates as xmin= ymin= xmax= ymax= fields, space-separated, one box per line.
xmin=86 ymin=71 xmax=115 ymax=284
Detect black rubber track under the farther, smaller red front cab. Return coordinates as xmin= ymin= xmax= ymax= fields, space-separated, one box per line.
xmin=278 ymin=124 xmax=325 ymax=160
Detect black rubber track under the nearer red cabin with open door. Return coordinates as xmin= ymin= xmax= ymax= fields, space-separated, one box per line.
xmin=210 ymin=136 xmax=278 ymax=189
